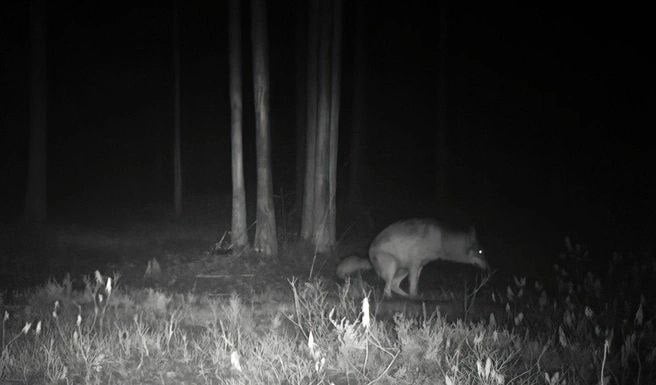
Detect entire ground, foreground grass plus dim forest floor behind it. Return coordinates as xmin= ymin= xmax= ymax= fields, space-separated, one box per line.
xmin=0 ymin=196 xmax=656 ymax=385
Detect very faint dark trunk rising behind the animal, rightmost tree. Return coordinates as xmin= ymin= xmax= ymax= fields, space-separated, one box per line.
xmin=435 ymin=1 xmax=449 ymax=200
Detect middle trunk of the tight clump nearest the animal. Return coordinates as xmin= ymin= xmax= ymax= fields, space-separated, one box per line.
xmin=314 ymin=2 xmax=332 ymax=252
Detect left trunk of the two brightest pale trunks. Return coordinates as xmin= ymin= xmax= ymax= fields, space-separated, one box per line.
xmin=228 ymin=0 xmax=248 ymax=249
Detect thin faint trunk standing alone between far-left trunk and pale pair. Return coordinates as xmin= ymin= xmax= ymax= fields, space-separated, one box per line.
xmin=172 ymin=0 xmax=182 ymax=218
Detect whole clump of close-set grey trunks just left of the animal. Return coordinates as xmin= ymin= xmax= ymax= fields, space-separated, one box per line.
xmin=301 ymin=1 xmax=342 ymax=252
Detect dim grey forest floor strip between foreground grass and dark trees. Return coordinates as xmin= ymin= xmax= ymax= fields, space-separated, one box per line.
xmin=0 ymin=195 xmax=499 ymax=319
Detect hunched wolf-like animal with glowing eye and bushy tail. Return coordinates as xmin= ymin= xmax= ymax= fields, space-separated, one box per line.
xmin=337 ymin=219 xmax=488 ymax=297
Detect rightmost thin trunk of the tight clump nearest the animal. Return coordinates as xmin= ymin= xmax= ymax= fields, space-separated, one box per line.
xmin=326 ymin=0 xmax=342 ymax=247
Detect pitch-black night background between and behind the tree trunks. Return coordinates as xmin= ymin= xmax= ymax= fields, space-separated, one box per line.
xmin=0 ymin=0 xmax=656 ymax=246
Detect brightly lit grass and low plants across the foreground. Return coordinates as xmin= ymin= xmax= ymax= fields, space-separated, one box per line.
xmin=0 ymin=224 xmax=656 ymax=385
